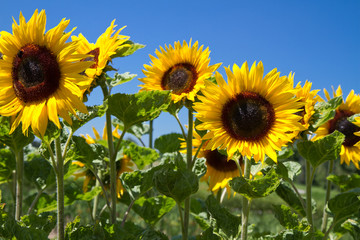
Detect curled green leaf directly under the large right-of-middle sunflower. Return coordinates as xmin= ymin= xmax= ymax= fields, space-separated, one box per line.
xmin=229 ymin=169 xmax=280 ymax=199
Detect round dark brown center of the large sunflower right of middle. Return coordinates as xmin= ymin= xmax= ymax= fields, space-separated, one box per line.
xmin=221 ymin=92 xmax=275 ymax=141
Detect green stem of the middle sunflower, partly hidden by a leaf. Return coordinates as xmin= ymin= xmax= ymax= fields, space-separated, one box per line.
xmin=183 ymin=108 xmax=194 ymax=240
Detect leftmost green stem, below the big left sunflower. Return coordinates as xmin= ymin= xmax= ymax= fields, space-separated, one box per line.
xmin=15 ymin=149 xmax=24 ymax=221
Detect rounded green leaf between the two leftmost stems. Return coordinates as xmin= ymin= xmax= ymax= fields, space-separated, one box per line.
xmin=24 ymin=154 xmax=55 ymax=189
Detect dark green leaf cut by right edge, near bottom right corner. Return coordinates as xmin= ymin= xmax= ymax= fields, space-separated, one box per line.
xmin=328 ymin=188 xmax=360 ymax=222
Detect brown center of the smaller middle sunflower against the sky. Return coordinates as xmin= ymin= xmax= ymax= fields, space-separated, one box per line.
xmin=161 ymin=63 xmax=198 ymax=95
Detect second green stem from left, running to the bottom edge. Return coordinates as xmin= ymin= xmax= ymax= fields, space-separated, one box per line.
xmin=55 ymin=137 xmax=65 ymax=240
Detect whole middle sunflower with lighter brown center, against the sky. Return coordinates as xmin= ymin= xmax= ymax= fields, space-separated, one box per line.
xmin=139 ymin=40 xmax=221 ymax=102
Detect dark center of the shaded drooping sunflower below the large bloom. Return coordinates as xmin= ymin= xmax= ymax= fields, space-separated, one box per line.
xmin=204 ymin=150 xmax=242 ymax=172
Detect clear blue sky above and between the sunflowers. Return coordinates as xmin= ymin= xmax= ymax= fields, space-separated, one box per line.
xmin=0 ymin=0 xmax=360 ymax=144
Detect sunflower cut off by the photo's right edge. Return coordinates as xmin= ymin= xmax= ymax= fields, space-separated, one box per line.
xmin=313 ymin=86 xmax=360 ymax=169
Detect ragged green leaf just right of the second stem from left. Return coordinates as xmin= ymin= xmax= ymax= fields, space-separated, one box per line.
xmin=66 ymin=136 xmax=108 ymax=166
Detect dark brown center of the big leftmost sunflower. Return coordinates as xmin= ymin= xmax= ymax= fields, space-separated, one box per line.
xmin=11 ymin=43 xmax=61 ymax=103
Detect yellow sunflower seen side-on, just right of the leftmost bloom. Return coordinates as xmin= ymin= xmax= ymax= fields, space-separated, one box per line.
xmin=71 ymin=20 xmax=129 ymax=85
